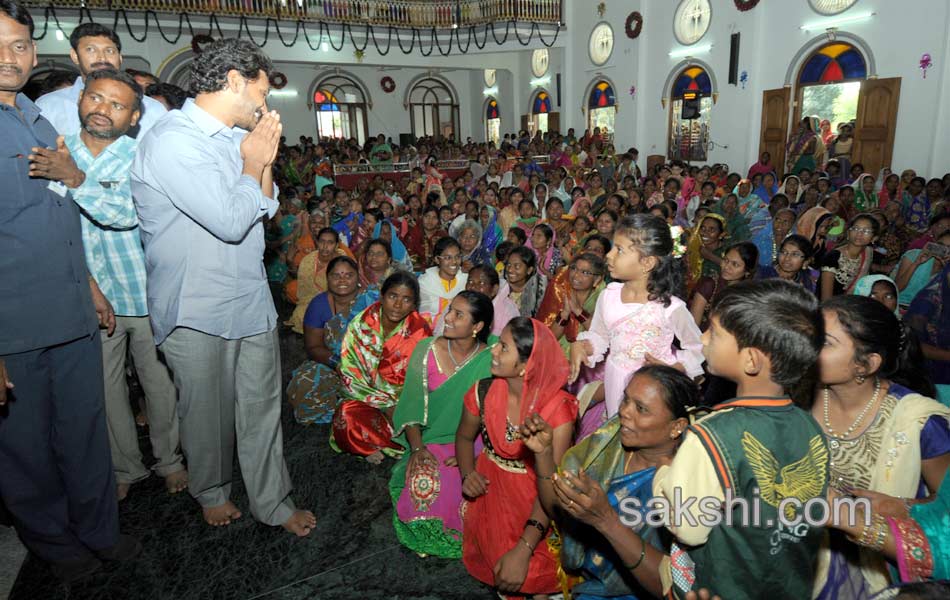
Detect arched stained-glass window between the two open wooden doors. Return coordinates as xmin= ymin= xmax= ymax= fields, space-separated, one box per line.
xmin=795 ymin=41 xmax=868 ymax=135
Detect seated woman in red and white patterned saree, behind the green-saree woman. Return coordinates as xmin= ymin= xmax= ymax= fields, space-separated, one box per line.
xmin=330 ymin=271 xmax=432 ymax=464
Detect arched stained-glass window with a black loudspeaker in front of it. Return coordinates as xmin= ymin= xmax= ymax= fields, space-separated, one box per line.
xmin=668 ymin=65 xmax=713 ymax=161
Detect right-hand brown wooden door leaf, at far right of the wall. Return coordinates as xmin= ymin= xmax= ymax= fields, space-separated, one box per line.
xmin=851 ymin=77 xmax=901 ymax=173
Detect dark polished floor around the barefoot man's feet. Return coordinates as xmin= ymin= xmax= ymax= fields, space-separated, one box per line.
xmin=10 ymin=292 xmax=497 ymax=600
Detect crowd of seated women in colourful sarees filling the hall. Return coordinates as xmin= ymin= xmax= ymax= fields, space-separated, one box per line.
xmin=267 ymin=133 xmax=950 ymax=599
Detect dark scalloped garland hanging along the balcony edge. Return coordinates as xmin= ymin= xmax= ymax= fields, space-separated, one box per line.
xmin=33 ymin=6 xmax=561 ymax=56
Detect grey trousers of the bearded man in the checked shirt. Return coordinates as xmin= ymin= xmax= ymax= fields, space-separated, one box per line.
xmin=102 ymin=316 xmax=184 ymax=483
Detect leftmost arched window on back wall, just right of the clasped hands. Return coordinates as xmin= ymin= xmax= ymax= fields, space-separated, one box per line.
xmin=313 ymin=75 xmax=367 ymax=144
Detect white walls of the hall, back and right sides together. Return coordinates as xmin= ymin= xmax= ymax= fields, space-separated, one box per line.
xmin=39 ymin=0 xmax=950 ymax=175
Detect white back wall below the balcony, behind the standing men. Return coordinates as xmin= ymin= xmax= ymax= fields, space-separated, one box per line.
xmin=37 ymin=10 xmax=565 ymax=140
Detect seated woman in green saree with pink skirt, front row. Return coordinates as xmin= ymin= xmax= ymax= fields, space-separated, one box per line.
xmin=389 ymin=290 xmax=494 ymax=558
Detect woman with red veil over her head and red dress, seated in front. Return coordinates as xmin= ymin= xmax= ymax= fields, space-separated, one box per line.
xmin=455 ymin=317 xmax=577 ymax=597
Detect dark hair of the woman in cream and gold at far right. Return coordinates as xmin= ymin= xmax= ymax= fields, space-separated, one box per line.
xmin=821 ymin=295 xmax=936 ymax=398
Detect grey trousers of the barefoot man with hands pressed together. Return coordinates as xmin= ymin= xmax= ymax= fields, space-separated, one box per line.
xmin=159 ymin=327 xmax=294 ymax=525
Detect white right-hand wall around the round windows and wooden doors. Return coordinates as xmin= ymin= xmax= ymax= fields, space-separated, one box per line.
xmin=562 ymin=0 xmax=950 ymax=175
